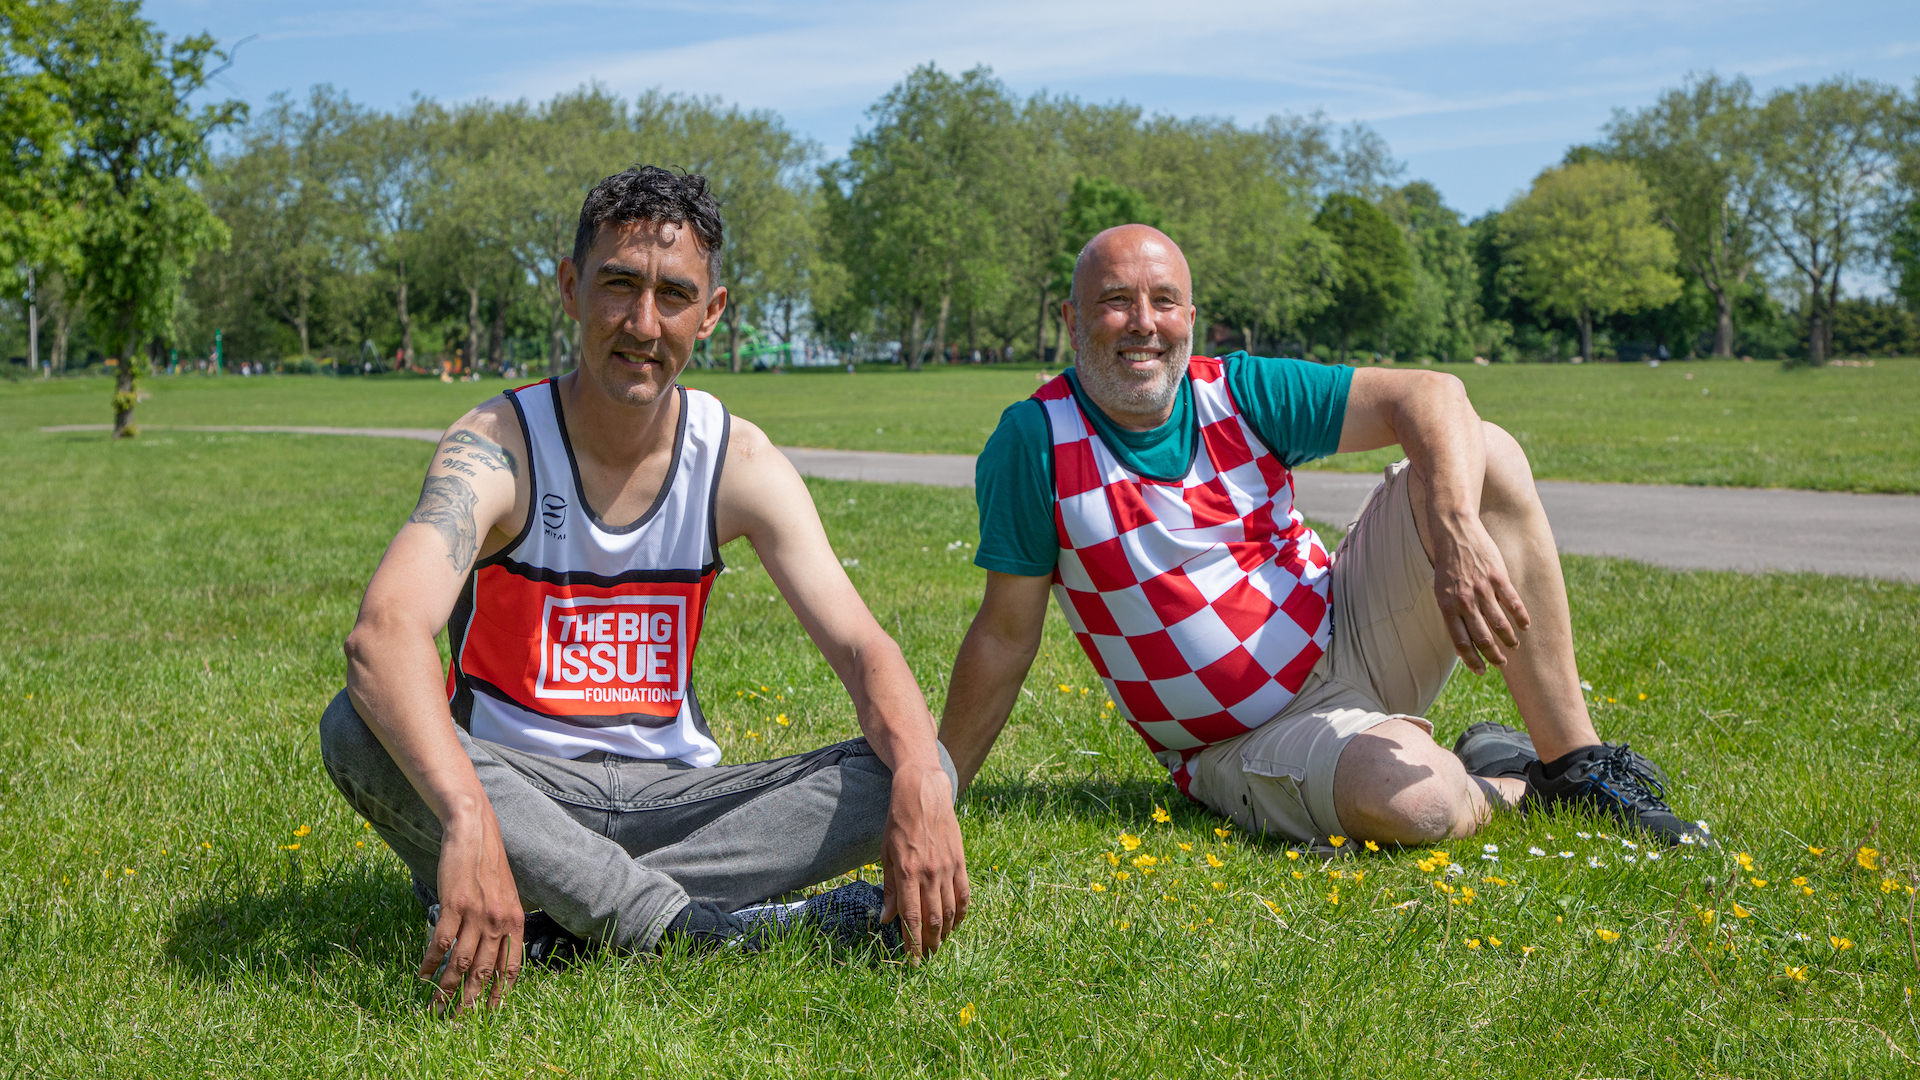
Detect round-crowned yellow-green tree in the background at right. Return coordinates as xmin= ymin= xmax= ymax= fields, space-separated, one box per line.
xmin=1505 ymin=161 xmax=1680 ymax=359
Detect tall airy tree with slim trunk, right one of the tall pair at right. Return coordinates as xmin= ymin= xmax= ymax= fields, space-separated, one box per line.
xmin=1761 ymin=79 xmax=1899 ymax=367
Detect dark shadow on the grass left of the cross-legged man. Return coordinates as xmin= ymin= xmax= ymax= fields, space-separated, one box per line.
xmin=161 ymin=863 xmax=426 ymax=1011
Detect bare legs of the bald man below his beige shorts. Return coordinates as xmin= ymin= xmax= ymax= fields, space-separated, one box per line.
xmin=1334 ymin=423 xmax=1599 ymax=844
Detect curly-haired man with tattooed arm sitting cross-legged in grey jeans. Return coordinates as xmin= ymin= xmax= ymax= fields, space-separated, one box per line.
xmin=321 ymin=167 xmax=968 ymax=1009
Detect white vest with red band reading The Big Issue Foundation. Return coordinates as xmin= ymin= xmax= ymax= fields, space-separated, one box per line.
xmin=447 ymin=379 xmax=730 ymax=767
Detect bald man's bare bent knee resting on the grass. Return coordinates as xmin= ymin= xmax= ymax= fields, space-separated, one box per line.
xmin=1334 ymin=721 xmax=1482 ymax=844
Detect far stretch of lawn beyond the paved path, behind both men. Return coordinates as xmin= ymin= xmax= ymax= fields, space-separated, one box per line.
xmin=0 ymin=359 xmax=1920 ymax=492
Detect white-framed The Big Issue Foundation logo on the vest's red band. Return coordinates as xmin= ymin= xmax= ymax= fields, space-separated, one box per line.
xmin=534 ymin=591 xmax=689 ymax=705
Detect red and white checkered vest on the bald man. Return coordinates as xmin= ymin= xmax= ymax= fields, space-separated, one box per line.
xmin=1033 ymin=356 xmax=1332 ymax=794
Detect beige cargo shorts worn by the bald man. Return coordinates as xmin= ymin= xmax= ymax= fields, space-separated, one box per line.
xmin=1188 ymin=461 xmax=1455 ymax=844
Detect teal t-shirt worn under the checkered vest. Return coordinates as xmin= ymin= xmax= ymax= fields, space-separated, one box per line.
xmin=973 ymin=352 xmax=1354 ymax=577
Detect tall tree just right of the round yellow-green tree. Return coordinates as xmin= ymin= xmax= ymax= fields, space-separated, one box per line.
xmin=1607 ymin=75 xmax=1772 ymax=357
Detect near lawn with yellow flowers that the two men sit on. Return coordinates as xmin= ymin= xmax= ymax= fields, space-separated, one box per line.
xmin=0 ymin=407 xmax=1920 ymax=1078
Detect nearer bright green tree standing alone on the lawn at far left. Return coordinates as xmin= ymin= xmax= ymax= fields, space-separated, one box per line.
xmin=21 ymin=0 xmax=246 ymax=438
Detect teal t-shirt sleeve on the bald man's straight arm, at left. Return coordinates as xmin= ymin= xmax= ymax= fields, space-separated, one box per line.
xmin=973 ymin=400 xmax=1060 ymax=577
